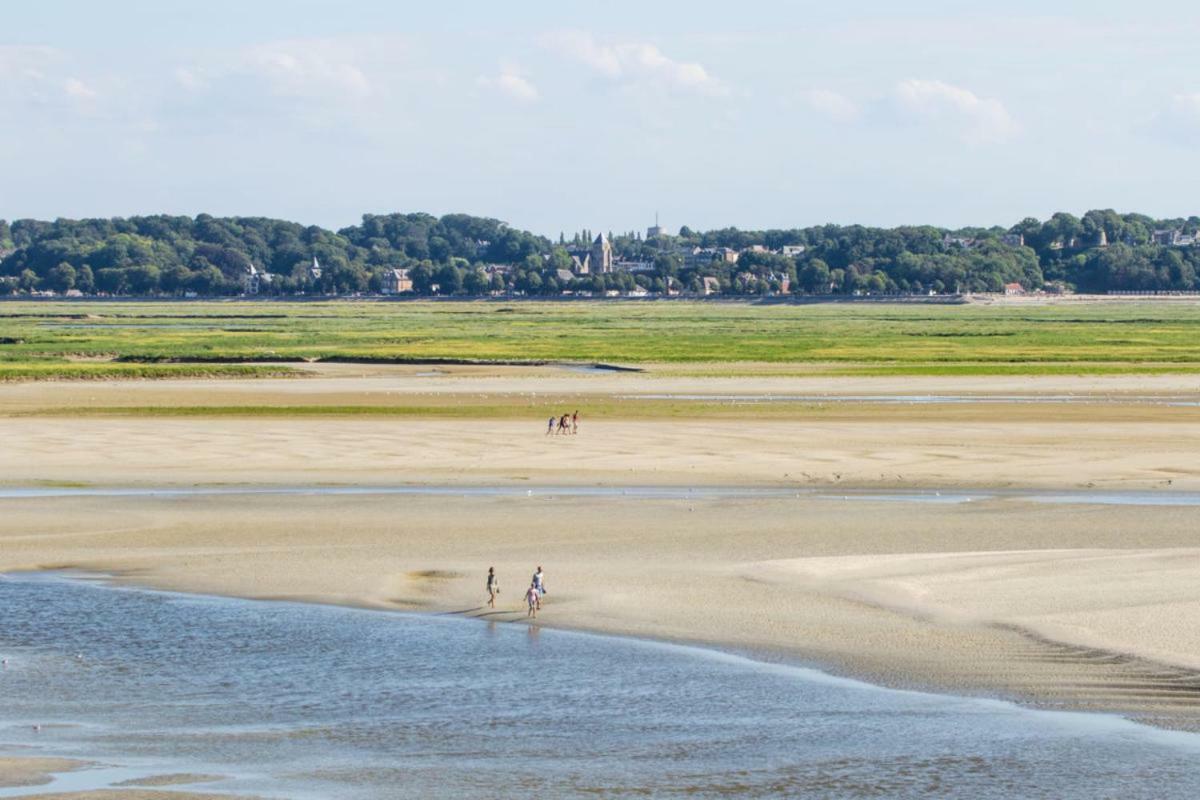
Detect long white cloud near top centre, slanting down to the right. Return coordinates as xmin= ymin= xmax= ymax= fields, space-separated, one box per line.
xmin=542 ymin=31 xmax=728 ymax=95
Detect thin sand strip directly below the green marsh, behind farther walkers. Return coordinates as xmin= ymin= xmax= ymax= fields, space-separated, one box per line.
xmin=0 ymin=363 xmax=1200 ymax=414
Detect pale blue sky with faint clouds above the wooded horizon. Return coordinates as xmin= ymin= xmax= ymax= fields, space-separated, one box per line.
xmin=0 ymin=0 xmax=1200 ymax=236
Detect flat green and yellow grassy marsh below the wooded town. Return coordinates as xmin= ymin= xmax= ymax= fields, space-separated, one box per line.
xmin=0 ymin=301 xmax=1200 ymax=380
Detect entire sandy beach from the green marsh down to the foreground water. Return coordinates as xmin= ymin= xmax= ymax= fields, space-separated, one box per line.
xmin=0 ymin=373 xmax=1200 ymax=796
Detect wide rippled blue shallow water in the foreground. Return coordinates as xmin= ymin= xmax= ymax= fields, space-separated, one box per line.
xmin=0 ymin=576 xmax=1200 ymax=799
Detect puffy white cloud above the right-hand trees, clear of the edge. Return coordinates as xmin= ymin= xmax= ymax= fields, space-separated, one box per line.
xmin=893 ymin=79 xmax=1019 ymax=143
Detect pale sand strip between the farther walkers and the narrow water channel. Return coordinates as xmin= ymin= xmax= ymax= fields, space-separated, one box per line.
xmin=0 ymin=417 xmax=1200 ymax=491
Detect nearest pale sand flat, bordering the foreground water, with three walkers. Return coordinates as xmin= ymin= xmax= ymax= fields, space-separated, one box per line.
xmin=0 ymin=495 xmax=1200 ymax=727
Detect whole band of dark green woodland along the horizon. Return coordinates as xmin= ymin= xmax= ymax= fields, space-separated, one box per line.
xmin=0 ymin=211 xmax=1200 ymax=296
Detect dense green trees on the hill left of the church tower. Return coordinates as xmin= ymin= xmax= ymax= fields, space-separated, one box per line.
xmin=0 ymin=213 xmax=550 ymax=295
